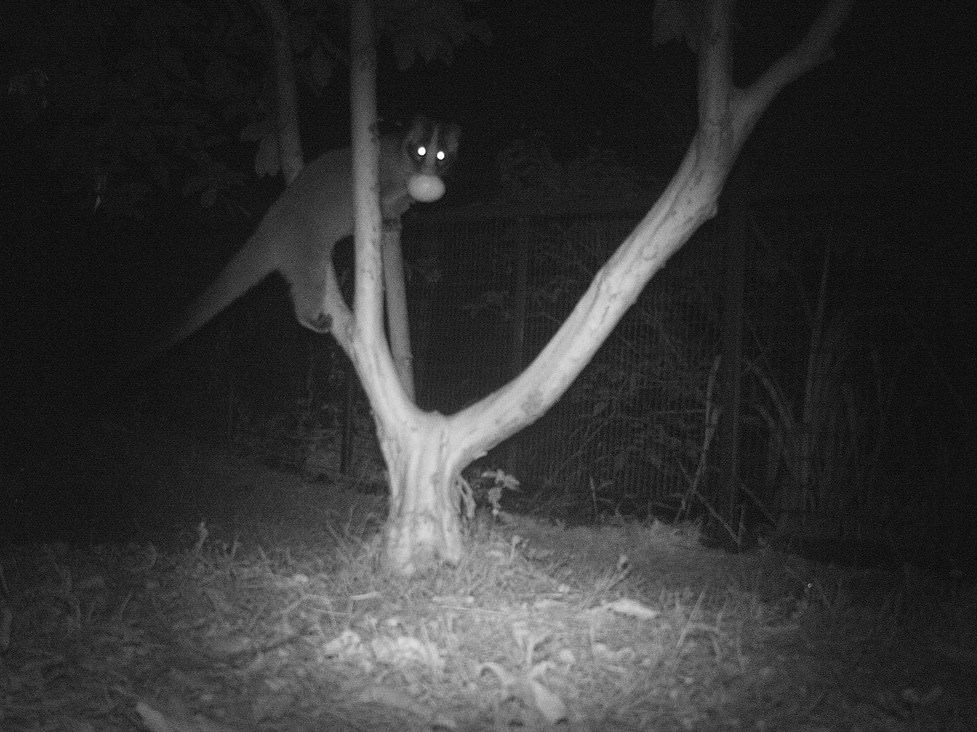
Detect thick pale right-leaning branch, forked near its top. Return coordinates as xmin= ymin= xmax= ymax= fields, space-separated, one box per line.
xmin=447 ymin=0 xmax=851 ymax=455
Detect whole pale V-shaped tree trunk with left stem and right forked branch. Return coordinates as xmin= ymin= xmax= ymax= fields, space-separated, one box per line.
xmin=344 ymin=0 xmax=851 ymax=575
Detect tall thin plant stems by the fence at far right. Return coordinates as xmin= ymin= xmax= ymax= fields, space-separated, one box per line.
xmin=746 ymin=243 xmax=893 ymax=532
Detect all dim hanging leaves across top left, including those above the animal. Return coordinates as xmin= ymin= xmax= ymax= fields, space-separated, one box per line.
xmin=5 ymin=0 xmax=490 ymax=219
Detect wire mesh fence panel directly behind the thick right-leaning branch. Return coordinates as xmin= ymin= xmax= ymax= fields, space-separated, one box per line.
xmin=405 ymin=207 xmax=722 ymax=515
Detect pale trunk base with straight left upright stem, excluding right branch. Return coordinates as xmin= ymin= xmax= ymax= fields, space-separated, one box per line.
xmin=342 ymin=0 xmax=464 ymax=575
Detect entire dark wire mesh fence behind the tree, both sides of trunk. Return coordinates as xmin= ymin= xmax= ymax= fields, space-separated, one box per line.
xmin=127 ymin=200 xmax=952 ymax=535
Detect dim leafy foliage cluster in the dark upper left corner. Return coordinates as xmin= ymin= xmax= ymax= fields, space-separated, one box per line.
xmin=5 ymin=0 xmax=260 ymax=218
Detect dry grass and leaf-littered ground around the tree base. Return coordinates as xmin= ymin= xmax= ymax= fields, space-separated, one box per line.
xmin=0 ymin=432 xmax=977 ymax=732
